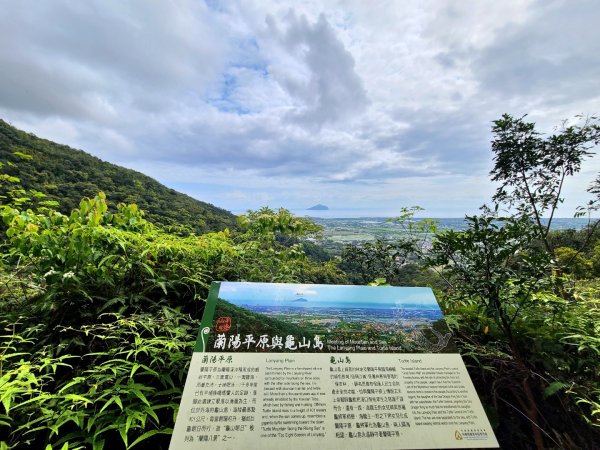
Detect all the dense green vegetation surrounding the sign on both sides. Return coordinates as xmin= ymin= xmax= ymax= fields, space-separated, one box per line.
xmin=0 ymin=116 xmax=600 ymax=449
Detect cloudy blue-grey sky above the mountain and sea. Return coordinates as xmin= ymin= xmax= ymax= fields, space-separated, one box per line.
xmin=0 ymin=0 xmax=600 ymax=217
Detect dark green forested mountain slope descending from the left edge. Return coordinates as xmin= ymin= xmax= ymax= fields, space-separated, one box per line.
xmin=0 ymin=119 xmax=236 ymax=233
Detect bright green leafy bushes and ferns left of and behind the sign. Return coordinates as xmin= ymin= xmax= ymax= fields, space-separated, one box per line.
xmin=0 ymin=160 xmax=343 ymax=450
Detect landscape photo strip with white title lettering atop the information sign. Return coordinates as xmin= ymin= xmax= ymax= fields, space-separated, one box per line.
xmin=206 ymin=283 xmax=457 ymax=353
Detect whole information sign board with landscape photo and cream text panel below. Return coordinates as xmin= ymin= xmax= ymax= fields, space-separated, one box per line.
xmin=170 ymin=282 xmax=498 ymax=450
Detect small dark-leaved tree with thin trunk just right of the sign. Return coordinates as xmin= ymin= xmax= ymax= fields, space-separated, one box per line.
xmin=428 ymin=210 xmax=551 ymax=448
